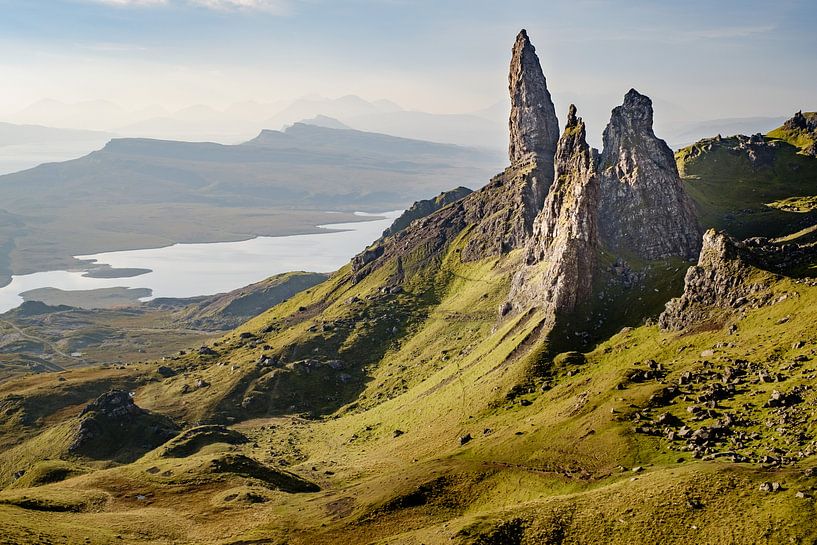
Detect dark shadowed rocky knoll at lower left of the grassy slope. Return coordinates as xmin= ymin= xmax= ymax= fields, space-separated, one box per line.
xmin=69 ymin=390 xmax=179 ymax=460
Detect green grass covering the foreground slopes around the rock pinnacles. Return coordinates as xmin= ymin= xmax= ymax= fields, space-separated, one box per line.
xmin=0 ymin=130 xmax=817 ymax=545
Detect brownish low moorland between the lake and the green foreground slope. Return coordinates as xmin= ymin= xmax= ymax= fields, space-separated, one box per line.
xmin=0 ymin=272 xmax=326 ymax=378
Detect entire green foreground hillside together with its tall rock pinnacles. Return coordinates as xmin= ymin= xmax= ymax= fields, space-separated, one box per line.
xmin=0 ymin=31 xmax=817 ymax=545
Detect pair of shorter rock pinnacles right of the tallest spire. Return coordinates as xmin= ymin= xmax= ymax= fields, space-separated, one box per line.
xmin=500 ymin=90 xmax=700 ymax=336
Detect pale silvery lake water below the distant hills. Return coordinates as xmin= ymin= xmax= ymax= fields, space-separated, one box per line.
xmin=0 ymin=211 xmax=401 ymax=312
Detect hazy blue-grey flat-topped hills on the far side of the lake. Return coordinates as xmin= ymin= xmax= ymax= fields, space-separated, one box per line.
xmin=0 ymin=124 xmax=501 ymax=281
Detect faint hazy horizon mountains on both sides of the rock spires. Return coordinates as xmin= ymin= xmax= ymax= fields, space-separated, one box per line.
xmin=6 ymin=95 xmax=796 ymax=153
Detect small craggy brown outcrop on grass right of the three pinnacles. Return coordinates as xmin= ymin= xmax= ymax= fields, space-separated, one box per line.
xmin=658 ymin=229 xmax=766 ymax=330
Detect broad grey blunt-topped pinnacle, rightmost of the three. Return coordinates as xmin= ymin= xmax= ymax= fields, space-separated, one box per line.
xmin=599 ymin=89 xmax=701 ymax=259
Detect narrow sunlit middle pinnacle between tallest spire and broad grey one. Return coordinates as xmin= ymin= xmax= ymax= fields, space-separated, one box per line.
xmin=505 ymin=105 xmax=599 ymax=320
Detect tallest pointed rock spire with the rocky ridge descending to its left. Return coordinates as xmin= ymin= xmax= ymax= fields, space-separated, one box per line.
xmin=352 ymin=30 xmax=559 ymax=281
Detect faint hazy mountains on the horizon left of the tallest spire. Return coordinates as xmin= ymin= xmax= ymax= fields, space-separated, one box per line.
xmin=10 ymin=95 xmax=507 ymax=149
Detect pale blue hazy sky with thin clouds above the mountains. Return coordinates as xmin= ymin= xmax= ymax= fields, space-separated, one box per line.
xmin=0 ymin=0 xmax=817 ymax=131
